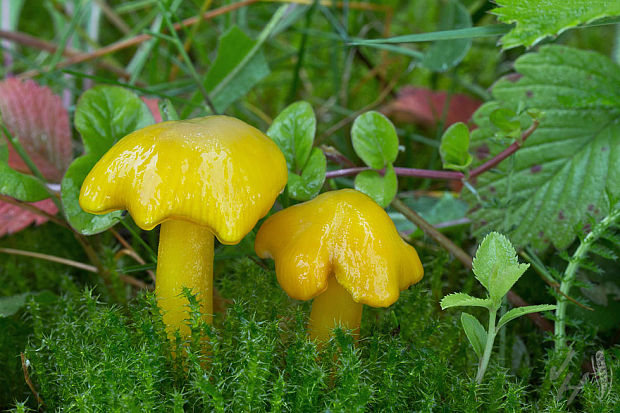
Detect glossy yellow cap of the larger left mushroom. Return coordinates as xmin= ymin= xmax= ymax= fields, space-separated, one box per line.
xmin=79 ymin=116 xmax=287 ymax=244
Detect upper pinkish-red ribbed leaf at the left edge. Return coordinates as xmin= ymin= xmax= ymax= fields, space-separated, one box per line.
xmin=0 ymin=78 xmax=72 ymax=182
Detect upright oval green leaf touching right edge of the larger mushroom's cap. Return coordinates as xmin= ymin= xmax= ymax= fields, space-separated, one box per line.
xmin=267 ymin=101 xmax=314 ymax=172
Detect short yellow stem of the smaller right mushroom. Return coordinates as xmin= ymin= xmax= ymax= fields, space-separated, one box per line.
xmin=308 ymin=277 xmax=363 ymax=342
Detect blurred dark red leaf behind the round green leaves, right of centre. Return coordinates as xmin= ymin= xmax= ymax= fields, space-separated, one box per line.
xmin=383 ymin=86 xmax=482 ymax=128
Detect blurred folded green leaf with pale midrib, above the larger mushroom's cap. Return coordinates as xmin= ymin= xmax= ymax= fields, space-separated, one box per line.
xmin=204 ymin=26 xmax=269 ymax=112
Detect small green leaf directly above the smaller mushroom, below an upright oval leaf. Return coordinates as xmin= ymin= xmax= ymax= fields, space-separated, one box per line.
xmin=288 ymin=148 xmax=327 ymax=201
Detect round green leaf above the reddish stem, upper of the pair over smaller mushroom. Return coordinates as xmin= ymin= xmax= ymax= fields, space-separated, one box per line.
xmin=351 ymin=111 xmax=398 ymax=169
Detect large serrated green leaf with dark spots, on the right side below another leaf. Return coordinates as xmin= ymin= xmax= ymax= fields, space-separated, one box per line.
xmin=465 ymin=45 xmax=620 ymax=249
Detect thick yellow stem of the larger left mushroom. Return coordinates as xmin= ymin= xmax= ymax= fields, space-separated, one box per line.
xmin=155 ymin=220 xmax=213 ymax=338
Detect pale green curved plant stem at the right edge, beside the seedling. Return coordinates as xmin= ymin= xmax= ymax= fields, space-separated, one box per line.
xmin=555 ymin=205 xmax=620 ymax=351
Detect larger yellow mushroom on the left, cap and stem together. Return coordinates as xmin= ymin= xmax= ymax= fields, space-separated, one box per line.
xmin=80 ymin=116 xmax=287 ymax=335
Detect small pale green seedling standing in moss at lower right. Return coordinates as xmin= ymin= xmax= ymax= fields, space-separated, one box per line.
xmin=441 ymin=232 xmax=556 ymax=383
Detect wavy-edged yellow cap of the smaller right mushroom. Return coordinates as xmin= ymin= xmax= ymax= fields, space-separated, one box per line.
xmin=254 ymin=189 xmax=424 ymax=307
